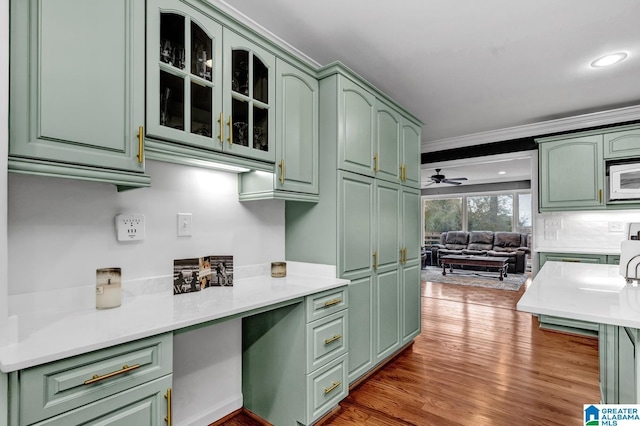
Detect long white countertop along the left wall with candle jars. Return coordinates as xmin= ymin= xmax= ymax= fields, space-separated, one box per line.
xmin=0 ymin=262 xmax=349 ymax=373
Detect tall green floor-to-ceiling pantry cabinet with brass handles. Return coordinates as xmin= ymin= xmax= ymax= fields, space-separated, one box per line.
xmin=285 ymin=64 xmax=422 ymax=383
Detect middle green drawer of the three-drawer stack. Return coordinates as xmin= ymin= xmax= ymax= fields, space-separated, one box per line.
xmin=307 ymin=310 xmax=348 ymax=373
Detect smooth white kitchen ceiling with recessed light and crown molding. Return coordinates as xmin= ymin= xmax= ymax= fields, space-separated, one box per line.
xmin=213 ymin=0 xmax=640 ymax=185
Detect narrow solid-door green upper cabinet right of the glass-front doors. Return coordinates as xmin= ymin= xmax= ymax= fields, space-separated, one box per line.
xmin=238 ymin=59 xmax=318 ymax=201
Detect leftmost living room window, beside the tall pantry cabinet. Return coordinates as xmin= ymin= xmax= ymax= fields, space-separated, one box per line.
xmin=424 ymin=197 xmax=462 ymax=245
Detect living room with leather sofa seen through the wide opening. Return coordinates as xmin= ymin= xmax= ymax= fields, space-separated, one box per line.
xmin=422 ymin=151 xmax=537 ymax=290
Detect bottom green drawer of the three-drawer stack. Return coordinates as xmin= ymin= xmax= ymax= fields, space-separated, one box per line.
xmin=307 ymin=354 xmax=349 ymax=423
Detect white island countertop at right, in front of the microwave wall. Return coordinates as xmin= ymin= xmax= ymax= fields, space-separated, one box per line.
xmin=517 ymin=262 xmax=640 ymax=328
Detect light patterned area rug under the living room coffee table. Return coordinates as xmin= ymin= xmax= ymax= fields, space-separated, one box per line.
xmin=422 ymin=266 xmax=529 ymax=291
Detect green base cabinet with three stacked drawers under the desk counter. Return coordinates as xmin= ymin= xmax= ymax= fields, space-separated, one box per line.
xmin=242 ymin=287 xmax=350 ymax=425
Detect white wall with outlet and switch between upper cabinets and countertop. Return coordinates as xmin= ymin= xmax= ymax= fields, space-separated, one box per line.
xmin=8 ymin=161 xmax=284 ymax=295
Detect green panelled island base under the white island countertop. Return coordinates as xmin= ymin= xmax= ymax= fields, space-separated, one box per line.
xmin=598 ymin=324 xmax=640 ymax=404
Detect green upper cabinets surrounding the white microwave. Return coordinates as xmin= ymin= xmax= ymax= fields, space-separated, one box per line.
xmin=536 ymin=125 xmax=640 ymax=212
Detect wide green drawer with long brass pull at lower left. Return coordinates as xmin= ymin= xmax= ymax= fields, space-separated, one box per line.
xmin=19 ymin=333 xmax=173 ymax=424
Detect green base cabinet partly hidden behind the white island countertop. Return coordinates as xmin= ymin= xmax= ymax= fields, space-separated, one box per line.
xmin=538 ymin=252 xmax=620 ymax=336
